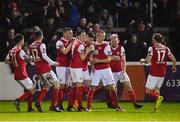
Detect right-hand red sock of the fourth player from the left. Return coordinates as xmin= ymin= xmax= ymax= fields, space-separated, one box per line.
xmin=76 ymin=86 xmax=84 ymax=107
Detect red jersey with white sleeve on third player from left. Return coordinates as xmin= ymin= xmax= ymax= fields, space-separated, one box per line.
xmin=56 ymin=38 xmax=71 ymax=67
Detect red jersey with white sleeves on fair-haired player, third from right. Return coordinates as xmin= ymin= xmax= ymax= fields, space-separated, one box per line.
xmin=93 ymin=42 xmax=111 ymax=70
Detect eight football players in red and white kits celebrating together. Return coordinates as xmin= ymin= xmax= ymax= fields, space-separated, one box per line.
xmin=5 ymin=27 xmax=176 ymax=112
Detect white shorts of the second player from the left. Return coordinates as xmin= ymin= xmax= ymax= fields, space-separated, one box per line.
xmin=41 ymin=70 xmax=58 ymax=83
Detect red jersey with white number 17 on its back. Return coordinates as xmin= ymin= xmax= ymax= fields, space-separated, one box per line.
xmin=148 ymin=44 xmax=171 ymax=77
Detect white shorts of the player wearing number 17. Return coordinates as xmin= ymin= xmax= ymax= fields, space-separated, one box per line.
xmin=146 ymin=75 xmax=164 ymax=89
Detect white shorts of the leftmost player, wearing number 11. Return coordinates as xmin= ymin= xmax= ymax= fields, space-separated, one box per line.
xmin=17 ymin=77 xmax=33 ymax=90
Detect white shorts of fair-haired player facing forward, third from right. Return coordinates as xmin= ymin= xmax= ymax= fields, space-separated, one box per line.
xmin=91 ymin=68 xmax=115 ymax=86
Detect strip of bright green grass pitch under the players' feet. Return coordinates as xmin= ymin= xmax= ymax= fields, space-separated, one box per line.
xmin=0 ymin=102 xmax=180 ymax=121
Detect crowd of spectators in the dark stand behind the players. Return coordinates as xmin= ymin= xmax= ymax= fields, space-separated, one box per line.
xmin=0 ymin=0 xmax=178 ymax=61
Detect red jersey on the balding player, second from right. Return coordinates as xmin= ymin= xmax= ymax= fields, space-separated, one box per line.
xmin=110 ymin=44 xmax=125 ymax=72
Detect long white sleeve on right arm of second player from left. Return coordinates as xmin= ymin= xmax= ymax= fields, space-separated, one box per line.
xmin=40 ymin=43 xmax=54 ymax=65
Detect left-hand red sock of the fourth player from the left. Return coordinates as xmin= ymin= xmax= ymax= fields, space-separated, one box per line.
xmin=68 ymin=88 xmax=76 ymax=107
